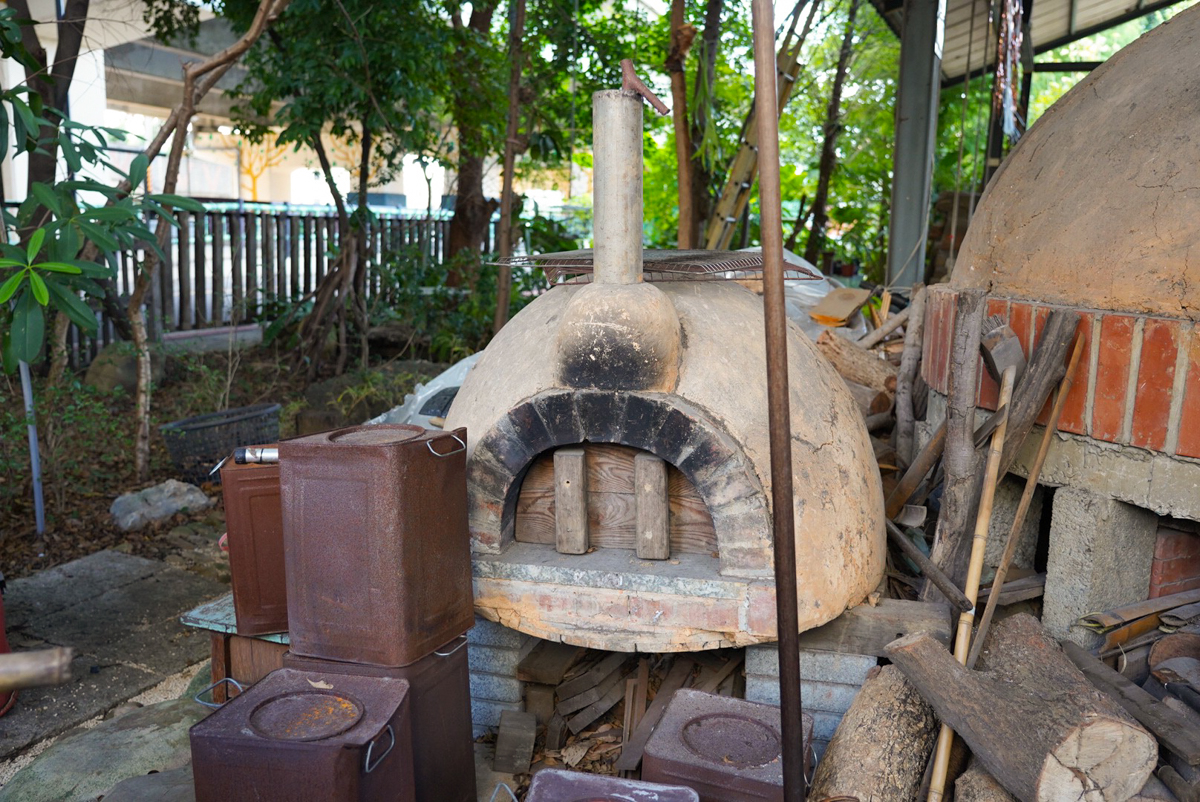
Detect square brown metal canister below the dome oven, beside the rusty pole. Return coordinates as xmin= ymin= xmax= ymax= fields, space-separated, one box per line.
xmin=642 ymin=689 xmax=812 ymax=802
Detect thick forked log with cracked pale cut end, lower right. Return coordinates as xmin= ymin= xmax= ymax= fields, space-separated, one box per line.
xmin=887 ymin=615 xmax=1158 ymax=802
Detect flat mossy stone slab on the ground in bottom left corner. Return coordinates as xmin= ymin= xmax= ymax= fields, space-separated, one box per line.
xmin=0 ymin=699 xmax=208 ymax=802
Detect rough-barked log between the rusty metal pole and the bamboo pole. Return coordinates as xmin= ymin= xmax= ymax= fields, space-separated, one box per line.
xmin=809 ymin=665 xmax=937 ymax=800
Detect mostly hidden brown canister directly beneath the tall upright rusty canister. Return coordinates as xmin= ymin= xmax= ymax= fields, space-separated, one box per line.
xmin=283 ymin=635 xmax=476 ymax=802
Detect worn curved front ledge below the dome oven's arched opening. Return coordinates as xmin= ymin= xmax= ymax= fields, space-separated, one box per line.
xmin=474 ymin=543 xmax=777 ymax=652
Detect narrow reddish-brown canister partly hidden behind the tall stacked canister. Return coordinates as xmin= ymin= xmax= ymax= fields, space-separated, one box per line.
xmin=221 ymin=444 xmax=288 ymax=635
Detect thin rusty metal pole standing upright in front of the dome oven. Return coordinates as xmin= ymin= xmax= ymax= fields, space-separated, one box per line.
xmin=751 ymin=0 xmax=806 ymax=802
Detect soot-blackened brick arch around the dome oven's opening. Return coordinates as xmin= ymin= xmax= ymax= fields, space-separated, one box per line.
xmin=467 ymin=390 xmax=773 ymax=576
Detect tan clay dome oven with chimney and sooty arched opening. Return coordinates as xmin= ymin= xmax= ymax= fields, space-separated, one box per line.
xmin=446 ymin=90 xmax=884 ymax=652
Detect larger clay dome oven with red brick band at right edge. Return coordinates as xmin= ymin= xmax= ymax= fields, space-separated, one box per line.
xmin=923 ymin=8 xmax=1200 ymax=642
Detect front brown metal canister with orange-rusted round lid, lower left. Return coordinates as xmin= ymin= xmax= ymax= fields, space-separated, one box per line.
xmin=190 ymin=669 xmax=415 ymax=802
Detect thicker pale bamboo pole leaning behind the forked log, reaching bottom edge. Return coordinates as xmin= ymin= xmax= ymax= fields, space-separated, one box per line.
xmin=929 ymin=365 xmax=1016 ymax=802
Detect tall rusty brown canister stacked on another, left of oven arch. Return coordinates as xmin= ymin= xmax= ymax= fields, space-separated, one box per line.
xmin=280 ymin=425 xmax=474 ymax=666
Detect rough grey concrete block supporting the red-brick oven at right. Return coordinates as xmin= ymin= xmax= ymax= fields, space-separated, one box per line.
xmin=1042 ymin=487 xmax=1158 ymax=648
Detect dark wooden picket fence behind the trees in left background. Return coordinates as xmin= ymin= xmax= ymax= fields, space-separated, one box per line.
xmin=67 ymin=204 xmax=470 ymax=367
